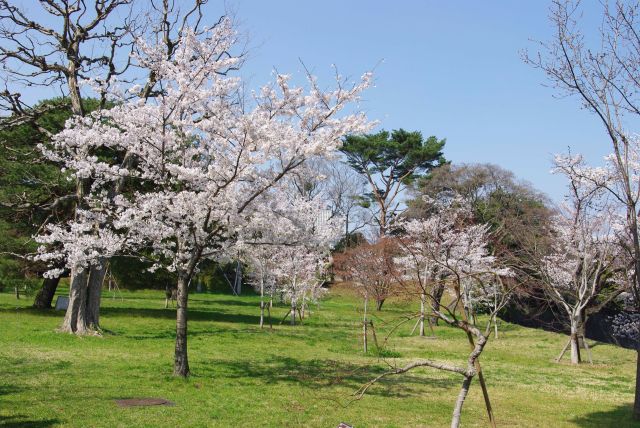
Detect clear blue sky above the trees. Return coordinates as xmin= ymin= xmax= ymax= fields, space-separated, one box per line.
xmin=12 ymin=0 xmax=609 ymax=200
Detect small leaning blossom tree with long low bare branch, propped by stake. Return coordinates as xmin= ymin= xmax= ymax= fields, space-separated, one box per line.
xmin=359 ymin=195 xmax=510 ymax=427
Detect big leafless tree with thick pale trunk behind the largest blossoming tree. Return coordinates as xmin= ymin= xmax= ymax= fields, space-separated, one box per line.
xmin=0 ymin=0 xmax=223 ymax=334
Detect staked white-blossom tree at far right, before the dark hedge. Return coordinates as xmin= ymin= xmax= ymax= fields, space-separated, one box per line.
xmin=544 ymin=155 xmax=628 ymax=364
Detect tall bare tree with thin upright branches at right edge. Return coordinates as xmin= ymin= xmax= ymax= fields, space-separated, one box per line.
xmin=524 ymin=0 xmax=640 ymax=419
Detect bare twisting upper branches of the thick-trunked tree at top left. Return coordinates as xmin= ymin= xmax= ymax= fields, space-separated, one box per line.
xmin=0 ymin=0 xmax=135 ymax=120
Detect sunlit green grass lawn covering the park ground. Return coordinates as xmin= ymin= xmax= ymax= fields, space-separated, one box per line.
xmin=0 ymin=284 xmax=636 ymax=428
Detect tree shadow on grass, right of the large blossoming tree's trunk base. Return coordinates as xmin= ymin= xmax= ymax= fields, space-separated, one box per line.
xmin=202 ymin=356 xmax=459 ymax=401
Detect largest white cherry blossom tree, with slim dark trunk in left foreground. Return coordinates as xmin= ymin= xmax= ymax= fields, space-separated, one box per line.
xmin=35 ymin=18 xmax=371 ymax=376
